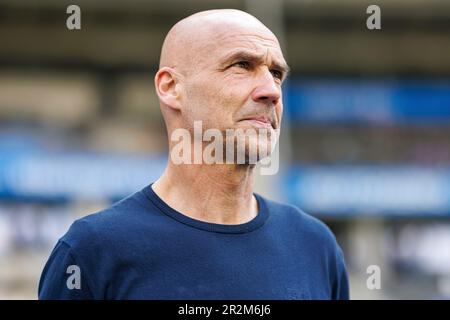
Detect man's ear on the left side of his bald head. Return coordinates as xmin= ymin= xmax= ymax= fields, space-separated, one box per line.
xmin=155 ymin=67 xmax=181 ymax=110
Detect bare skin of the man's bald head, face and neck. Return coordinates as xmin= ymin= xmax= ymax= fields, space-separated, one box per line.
xmin=153 ymin=9 xmax=288 ymax=224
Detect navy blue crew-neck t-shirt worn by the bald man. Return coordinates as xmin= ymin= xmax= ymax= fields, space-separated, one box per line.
xmin=39 ymin=185 xmax=349 ymax=300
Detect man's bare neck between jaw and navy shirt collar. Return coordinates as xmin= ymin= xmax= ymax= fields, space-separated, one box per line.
xmin=152 ymin=162 xmax=258 ymax=224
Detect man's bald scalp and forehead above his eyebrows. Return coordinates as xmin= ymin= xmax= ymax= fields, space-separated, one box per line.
xmin=160 ymin=9 xmax=284 ymax=66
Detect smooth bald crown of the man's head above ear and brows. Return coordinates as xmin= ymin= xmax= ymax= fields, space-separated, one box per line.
xmin=159 ymin=9 xmax=278 ymax=71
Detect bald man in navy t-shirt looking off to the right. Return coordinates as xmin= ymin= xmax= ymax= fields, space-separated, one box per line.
xmin=39 ymin=10 xmax=349 ymax=299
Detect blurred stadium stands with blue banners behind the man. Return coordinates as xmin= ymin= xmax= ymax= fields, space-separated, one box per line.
xmin=0 ymin=0 xmax=450 ymax=299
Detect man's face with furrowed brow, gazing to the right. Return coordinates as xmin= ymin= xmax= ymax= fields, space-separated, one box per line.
xmin=179 ymin=23 xmax=287 ymax=162
